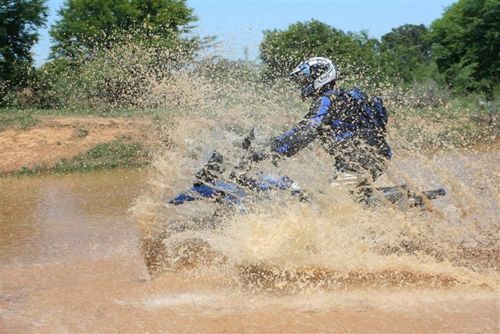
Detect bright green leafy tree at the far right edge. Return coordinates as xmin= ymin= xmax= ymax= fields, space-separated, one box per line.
xmin=431 ymin=0 xmax=500 ymax=94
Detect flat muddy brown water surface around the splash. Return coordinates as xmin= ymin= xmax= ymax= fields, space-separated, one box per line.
xmin=0 ymin=150 xmax=500 ymax=333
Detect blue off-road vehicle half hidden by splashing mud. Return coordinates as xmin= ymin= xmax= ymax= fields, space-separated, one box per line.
xmin=142 ymin=132 xmax=446 ymax=274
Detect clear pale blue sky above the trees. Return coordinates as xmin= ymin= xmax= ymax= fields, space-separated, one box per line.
xmin=33 ymin=0 xmax=456 ymax=65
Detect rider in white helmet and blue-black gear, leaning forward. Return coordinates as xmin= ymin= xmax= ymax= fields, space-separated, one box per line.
xmin=250 ymin=57 xmax=392 ymax=195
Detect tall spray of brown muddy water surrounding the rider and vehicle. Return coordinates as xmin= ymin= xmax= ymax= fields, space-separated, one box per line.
xmin=119 ymin=41 xmax=500 ymax=290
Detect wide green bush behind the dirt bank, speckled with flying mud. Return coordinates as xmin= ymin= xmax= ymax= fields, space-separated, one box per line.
xmin=4 ymin=39 xmax=196 ymax=109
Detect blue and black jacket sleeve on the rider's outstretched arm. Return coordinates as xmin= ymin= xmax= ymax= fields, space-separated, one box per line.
xmin=271 ymin=96 xmax=331 ymax=156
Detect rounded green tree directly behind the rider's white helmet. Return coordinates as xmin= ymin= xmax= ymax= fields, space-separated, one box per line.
xmin=260 ymin=20 xmax=379 ymax=87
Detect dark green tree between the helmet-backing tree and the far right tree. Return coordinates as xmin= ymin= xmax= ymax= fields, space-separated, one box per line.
xmin=380 ymin=24 xmax=432 ymax=83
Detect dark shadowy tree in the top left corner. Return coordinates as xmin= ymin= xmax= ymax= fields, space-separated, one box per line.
xmin=0 ymin=0 xmax=47 ymax=90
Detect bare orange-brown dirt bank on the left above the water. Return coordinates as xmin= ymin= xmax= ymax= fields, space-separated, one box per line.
xmin=0 ymin=116 xmax=155 ymax=174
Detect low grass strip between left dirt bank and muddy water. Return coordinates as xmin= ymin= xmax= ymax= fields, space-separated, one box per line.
xmin=13 ymin=140 xmax=149 ymax=176
